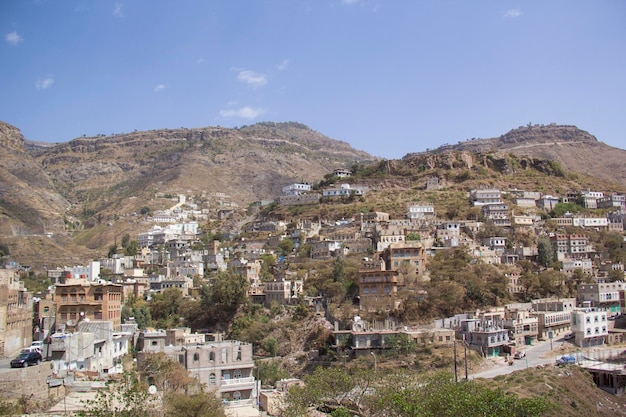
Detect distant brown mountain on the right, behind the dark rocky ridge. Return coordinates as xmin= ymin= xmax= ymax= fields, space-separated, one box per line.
xmin=414 ymin=124 xmax=626 ymax=188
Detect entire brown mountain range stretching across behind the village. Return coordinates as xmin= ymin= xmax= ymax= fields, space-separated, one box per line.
xmin=0 ymin=122 xmax=626 ymax=265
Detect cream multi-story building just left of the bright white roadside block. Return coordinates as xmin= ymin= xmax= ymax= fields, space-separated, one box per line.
xmin=530 ymin=298 xmax=576 ymax=339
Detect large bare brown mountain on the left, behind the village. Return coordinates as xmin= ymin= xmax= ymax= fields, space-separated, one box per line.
xmin=0 ymin=123 xmax=376 ymax=263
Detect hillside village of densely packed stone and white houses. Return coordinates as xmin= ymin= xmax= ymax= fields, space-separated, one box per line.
xmin=0 ymin=162 xmax=626 ymax=413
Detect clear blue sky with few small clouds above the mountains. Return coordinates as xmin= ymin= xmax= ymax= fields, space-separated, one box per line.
xmin=0 ymin=0 xmax=626 ymax=158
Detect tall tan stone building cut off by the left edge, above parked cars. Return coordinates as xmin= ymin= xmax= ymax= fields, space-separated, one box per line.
xmin=0 ymin=269 xmax=33 ymax=356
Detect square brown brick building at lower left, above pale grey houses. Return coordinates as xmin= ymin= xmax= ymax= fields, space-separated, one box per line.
xmin=54 ymin=279 xmax=123 ymax=331
